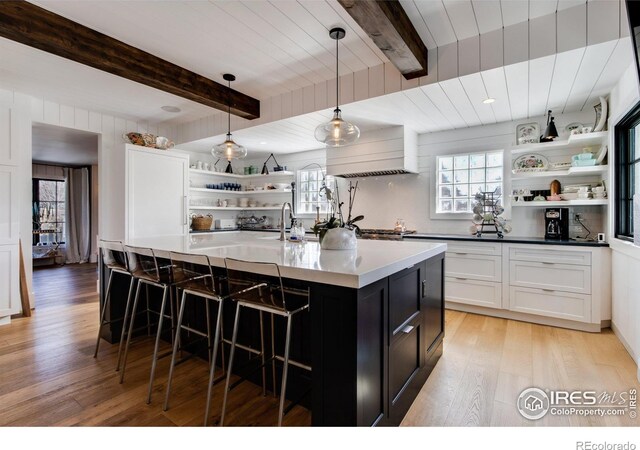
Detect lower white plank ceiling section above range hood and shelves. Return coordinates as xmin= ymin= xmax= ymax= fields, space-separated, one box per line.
xmin=180 ymin=38 xmax=633 ymax=153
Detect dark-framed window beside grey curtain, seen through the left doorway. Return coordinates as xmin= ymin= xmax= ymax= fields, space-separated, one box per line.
xmin=32 ymin=178 xmax=65 ymax=245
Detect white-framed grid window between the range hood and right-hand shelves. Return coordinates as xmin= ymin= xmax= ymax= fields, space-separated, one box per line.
xmin=436 ymin=151 xmax=503 ymax=214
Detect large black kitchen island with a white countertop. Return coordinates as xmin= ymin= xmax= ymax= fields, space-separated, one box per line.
xmin=101 ymin=231 xmax=446 ymax=426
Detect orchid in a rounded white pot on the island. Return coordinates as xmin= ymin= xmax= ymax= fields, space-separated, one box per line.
xmin=313 ymin=181 xmax=364 ymax=250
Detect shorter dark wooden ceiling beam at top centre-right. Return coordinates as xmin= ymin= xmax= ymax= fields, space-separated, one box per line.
xmin=338 ymin=0 xmax=428 ymax=80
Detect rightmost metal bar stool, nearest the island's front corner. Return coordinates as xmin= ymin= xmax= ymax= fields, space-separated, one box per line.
xmin=219 ymin=258 xmax=311 ymax=426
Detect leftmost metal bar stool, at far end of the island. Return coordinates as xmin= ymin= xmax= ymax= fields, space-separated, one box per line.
xmin=93 ymin=239 xmax=135 ymax=362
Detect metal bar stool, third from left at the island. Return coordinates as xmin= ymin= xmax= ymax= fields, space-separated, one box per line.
xmin=163 ymin=252 xmax=224 ymax=417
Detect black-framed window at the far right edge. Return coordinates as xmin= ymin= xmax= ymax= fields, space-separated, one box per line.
xmin=615 ymin=103 xmax=640 ymax=240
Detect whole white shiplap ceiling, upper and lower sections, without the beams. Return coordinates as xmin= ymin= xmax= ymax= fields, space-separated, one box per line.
xmin=0 ymin=0 xmax=631 ymax=153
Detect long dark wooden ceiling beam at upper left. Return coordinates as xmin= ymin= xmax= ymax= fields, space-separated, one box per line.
xmin=0 ymin=0 xmax=260 ymax=119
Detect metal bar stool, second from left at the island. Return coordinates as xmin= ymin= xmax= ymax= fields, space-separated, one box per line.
xmin=120 ymin=245 xmax=175 ymax=404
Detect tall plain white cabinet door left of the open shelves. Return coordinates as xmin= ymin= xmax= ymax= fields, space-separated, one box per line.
xmin=126 ymin=145 xmax=189 ymax=239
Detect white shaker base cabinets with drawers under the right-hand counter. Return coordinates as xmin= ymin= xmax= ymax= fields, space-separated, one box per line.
xmin=445 ymin=241 xmax=611 ymax=331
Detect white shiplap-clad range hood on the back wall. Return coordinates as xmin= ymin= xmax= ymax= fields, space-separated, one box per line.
xmin=327 ymin=126 xmax=418 ymax=178
